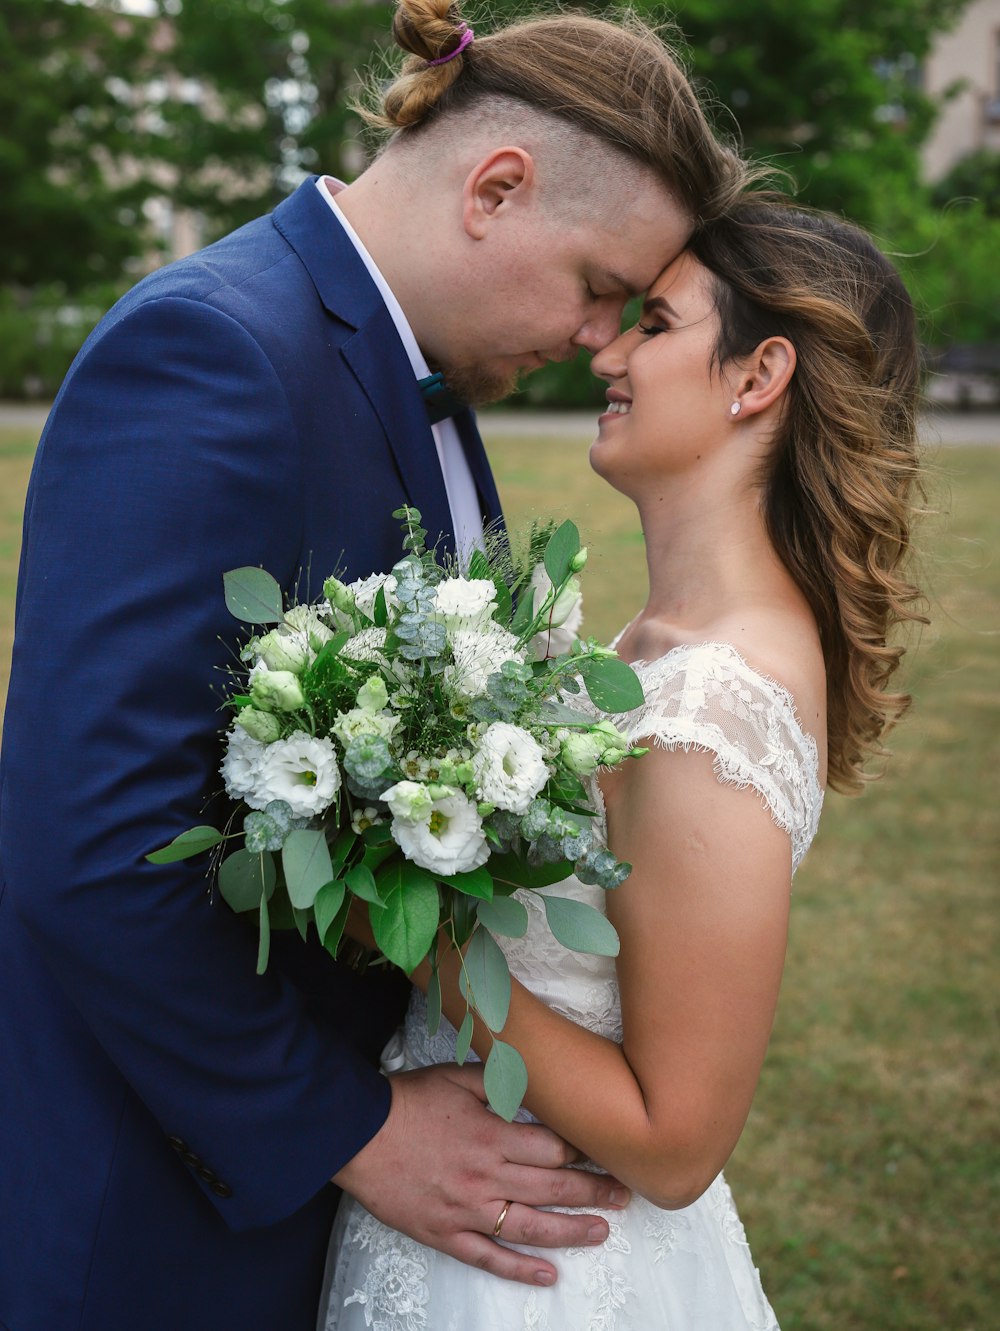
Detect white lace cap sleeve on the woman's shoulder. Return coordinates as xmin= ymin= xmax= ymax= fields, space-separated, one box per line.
xmin=625 ymin=643 xmax=823 ymax=872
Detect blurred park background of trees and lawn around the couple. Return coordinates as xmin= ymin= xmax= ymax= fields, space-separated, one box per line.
xmin=0 ymin=0 xmax=1000 ymax=1331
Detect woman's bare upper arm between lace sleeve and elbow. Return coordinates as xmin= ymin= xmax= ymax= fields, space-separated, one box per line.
xmin=606 ymin=748 xmax=791 ymax=1175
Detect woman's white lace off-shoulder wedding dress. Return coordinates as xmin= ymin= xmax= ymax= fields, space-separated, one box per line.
xmin=318 ymin=643 xmax=823 ymax=1331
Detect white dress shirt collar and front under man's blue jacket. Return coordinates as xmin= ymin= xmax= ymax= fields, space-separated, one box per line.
xmin=316 ymin=176 xmax=483 ymax=566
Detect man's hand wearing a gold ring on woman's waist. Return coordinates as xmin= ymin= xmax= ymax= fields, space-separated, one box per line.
xmin=333 ymin=1063 xmax=628 ymax=1284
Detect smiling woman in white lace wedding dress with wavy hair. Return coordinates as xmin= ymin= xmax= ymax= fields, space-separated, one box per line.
xmin=320 ymin=197 xmax=917 ymax=1331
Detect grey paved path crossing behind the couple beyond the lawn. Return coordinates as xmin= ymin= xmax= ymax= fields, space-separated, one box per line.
xmin=0 ymin=402 xmax=1000 ymax=447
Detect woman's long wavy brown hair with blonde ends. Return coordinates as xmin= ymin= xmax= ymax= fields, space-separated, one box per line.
xmin=691 ymin=196 xmax=925 ymax=791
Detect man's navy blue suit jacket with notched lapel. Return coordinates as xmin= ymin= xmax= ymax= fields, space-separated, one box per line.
xmin=0 ymin=181 xmax=499 ymax=1331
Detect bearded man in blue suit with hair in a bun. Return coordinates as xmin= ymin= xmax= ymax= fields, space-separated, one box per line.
xmin=0 ymin=5 xmax=735 ymax=1331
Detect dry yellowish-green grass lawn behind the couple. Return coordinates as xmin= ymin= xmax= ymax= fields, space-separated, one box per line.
xmin=0 ymin=425 xmax=1000 ymax=1331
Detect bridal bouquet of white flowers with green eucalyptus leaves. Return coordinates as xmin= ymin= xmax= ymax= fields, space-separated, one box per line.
xmin=148 ymin=508 xmax=646 ymax=1118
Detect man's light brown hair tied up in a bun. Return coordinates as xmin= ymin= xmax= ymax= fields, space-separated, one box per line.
xmin=361 ymin=0 xmax=748 ymax=224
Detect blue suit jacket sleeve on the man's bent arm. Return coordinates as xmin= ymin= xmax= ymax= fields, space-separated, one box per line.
xmin=3 ymin=297 xmax=389 ymax=1229
